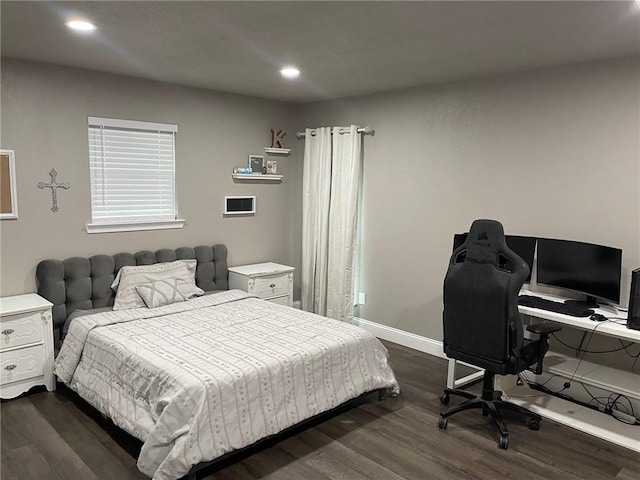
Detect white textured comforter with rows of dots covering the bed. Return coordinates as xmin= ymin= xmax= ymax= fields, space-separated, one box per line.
xmin=55 ymin=290 xmax=399 ymax=480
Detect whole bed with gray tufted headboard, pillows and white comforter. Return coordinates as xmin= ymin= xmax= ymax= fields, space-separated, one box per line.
xmin=36 ymin=245 xmax=399 ymax=480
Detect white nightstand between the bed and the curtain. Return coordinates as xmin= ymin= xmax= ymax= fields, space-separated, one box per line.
xmin=229 ymin=262 xmax=295 ymax=307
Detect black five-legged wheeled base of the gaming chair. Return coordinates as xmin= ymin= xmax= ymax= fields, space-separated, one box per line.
xmin=438 ymin=371 xmax=542 ymax=450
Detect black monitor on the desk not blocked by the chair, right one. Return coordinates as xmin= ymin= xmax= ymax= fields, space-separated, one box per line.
xmin=537 ymin=238 xmax=622 ymax=308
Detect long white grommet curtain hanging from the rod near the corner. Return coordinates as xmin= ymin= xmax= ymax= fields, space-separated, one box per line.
xmin=302 ymin=125 xmax=362 ymax=321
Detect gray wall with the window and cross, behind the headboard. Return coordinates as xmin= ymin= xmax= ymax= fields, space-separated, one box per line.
xmin=0 ymin=59 xmax=303 ymax=297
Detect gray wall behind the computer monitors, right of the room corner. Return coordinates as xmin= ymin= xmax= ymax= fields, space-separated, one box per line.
xmin=303 ymin=58 xmax=640 ymax=340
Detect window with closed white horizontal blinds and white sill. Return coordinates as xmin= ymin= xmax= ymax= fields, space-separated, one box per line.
xmin=87 ymin=117 xmax=184 ymax=233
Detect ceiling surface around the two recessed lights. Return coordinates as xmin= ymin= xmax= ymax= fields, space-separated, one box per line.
xmin=0 ymin=1 xmax=640 ymax=102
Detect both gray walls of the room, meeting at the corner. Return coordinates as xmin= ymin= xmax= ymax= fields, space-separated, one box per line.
xmin=0 ymin=58 xmax=640 ymax=348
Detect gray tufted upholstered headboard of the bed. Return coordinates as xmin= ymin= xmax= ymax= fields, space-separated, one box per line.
xmin=36 ymin=245 xmax=229 ymax=328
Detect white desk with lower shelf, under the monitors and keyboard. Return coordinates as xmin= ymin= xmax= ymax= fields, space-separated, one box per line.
xmin=447 ymin=290 xmax=640 ymax=452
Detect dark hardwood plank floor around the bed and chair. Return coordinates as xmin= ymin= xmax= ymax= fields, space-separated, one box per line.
xmin=0 ymin=342 xmax=640 ymax=480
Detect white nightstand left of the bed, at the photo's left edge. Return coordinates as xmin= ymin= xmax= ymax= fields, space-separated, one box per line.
xmin=0 ymin=293 xmax=56 ymax=398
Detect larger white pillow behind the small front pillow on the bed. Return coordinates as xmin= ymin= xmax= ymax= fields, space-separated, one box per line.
xmin=111 ymin=260 xmax=204 ymax=310
